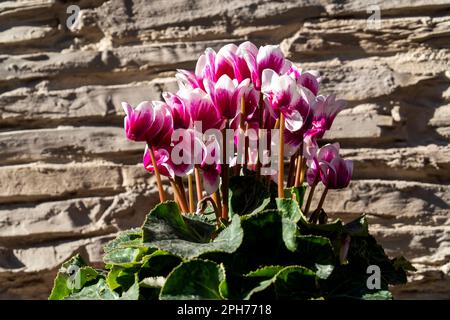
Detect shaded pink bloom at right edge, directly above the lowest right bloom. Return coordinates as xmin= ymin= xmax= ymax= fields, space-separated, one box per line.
xmin=306 ymin=95 xmax=345 ymax=139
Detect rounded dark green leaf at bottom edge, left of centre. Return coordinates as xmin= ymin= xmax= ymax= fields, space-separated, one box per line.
xmin=160 ymin=260 xmax=225 ymax=300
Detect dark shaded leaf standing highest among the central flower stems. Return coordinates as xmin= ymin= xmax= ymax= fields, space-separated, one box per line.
xmin=229 ymin=176 xmax=270 ymax=216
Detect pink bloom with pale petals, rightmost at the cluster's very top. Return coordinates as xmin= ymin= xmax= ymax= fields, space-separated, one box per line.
xmin=244 ymin=45 xmax=291 ymax=90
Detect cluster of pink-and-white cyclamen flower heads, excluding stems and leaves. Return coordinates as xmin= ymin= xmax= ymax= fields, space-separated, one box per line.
xmin=123 ymin=42 xmax=352 ymax=200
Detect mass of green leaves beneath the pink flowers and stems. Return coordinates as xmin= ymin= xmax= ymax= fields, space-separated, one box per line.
xmin=49 ymin=177 xmax=413 ymax=300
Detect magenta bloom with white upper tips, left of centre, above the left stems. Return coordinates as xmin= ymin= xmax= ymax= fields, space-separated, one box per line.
xmin=179 ymin=88 xmax=223 ymax=132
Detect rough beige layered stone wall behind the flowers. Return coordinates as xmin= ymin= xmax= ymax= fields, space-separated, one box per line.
xmin=0 ymin=0 xmax=450 ymax=299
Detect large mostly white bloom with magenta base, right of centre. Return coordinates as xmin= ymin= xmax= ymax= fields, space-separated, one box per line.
xmin=261 ymin=69 xmax=314 ymax=132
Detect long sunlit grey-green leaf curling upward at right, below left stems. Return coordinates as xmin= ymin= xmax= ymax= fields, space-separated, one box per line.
xmin=145 ymin=215 xmax=243 ymax=259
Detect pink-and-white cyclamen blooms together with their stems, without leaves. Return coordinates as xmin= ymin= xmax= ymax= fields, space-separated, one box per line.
xmin=123 ymin=42 xmax=353 ymax=220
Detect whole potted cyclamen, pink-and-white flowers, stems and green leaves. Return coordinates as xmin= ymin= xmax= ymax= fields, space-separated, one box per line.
xmin=50 ymin=42 xmax=412 ymax=299
